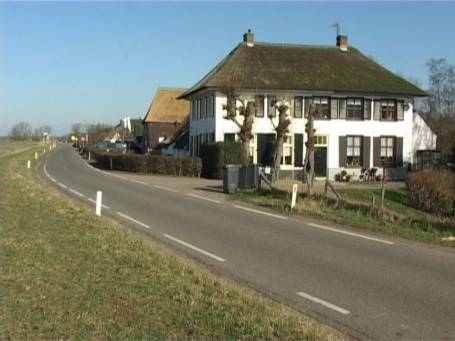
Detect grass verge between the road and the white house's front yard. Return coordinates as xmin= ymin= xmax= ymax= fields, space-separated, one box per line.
xmin=232 ymin=189 xmax=455 ymax=247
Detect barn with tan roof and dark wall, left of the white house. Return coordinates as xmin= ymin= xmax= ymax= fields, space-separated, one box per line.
xmin=144 ymin=88 xmax=190 ymax=151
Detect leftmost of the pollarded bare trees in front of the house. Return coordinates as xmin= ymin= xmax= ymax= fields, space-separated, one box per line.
xmin=223 ymin=86 xmax=255 ymax=159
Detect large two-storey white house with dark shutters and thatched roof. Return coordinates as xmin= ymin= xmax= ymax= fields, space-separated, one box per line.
xmin=180 ymin=31 xmax=436 ymax=179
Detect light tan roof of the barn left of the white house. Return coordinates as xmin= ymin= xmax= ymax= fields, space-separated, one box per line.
xmin=144 ymin=88 xmax=190 ymax=123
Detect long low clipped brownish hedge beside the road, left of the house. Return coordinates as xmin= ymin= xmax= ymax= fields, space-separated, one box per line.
xmin=93 ymin=152 xmax=202 ymax=176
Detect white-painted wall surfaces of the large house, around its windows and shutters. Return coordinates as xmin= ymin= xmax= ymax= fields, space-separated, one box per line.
xmin=190 ymin=91 xmax=436 ymax=179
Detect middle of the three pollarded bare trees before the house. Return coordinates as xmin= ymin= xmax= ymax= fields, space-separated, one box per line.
xmin=269 ymin=100 xmax=291 ymax=181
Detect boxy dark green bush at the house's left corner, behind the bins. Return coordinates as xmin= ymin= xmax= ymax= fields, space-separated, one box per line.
xmin=201 ymin=142 xmax=248 ymax=179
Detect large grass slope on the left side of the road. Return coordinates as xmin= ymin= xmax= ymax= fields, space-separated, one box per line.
xmin=0 ymin=142 xmax=343 ymax=340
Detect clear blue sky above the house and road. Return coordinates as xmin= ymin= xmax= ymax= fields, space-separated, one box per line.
xmin=0 ymin=2 xmax=455 ymax=135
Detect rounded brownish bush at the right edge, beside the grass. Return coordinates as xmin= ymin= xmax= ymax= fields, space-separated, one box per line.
xmin=406 ymin=171 xmax=455 ymax=216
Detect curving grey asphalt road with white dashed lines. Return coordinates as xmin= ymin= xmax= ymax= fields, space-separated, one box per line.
xmin=42 ymin=145 xmax=455 ymax=340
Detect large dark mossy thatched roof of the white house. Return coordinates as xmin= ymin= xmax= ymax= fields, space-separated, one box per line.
xmin=179 ymin=43 xmax=427 ymax=98
